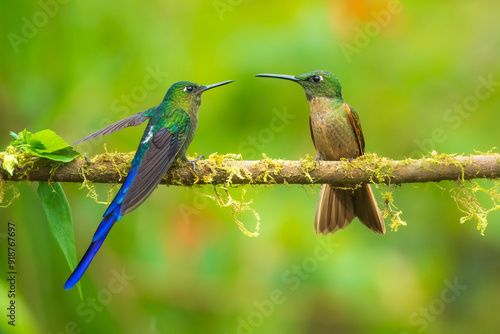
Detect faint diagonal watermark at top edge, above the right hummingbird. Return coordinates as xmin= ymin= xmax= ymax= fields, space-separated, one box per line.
xmin=339 ymin=0 xmax=403 ymax=64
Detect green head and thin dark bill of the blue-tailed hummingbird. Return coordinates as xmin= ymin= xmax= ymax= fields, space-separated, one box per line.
xmin=163 ymin=80 xmax=233 ymax=111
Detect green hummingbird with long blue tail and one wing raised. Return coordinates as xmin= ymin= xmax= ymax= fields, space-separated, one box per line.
xmin=64 ymin=80 xmax=233 ymax=289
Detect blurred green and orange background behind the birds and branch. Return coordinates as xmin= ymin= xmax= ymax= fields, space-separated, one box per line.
xmin=0 ymin=0 xmax=500 ymax=334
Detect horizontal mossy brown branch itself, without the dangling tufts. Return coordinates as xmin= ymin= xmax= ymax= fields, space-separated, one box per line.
xmin=0 ymin=152 xmax=500 ymax=187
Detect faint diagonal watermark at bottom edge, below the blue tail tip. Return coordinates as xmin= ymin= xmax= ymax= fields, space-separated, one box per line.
xmin=49 ymin=269 xmax=135 ymax=334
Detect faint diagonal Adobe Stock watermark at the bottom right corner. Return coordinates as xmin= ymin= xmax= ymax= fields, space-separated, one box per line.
xmin=401 ymin=277 xmax=467 ymax=334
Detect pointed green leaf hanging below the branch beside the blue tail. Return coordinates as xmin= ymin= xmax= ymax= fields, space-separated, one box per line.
xmin=37 ymin=182 xmax=82 ymax=298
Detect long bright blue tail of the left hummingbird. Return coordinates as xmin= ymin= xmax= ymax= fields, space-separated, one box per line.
xmin=64 ymin=165 xmax=138 ymax=290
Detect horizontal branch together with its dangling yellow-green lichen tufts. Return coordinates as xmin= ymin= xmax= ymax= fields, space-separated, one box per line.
xmin=0 ymin=150 xmax=500 ymax=236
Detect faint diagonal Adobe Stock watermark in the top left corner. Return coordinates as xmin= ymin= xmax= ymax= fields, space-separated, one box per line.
xmin=7 ymin=0 xmax=69 ymax=53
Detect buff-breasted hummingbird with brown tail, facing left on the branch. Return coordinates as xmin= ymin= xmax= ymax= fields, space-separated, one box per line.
xmin=256 ymin=71 xmax=385 ymax=234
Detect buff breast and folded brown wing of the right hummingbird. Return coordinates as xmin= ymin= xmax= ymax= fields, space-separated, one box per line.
xmin=310 ymin=97 xmax=361 ymax=160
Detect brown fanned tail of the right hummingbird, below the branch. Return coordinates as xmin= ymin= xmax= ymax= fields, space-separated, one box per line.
xmin=314 ymin=184 xmax=385 ymax=234
